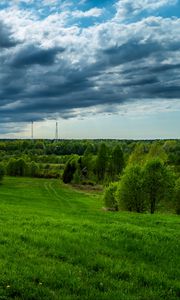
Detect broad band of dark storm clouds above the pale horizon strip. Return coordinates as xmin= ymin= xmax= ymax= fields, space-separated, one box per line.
xmin=0 ymin=21 xmax=180 ymax=122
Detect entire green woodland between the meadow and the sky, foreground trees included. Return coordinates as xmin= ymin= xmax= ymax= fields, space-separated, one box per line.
xmin=0 ymin=140 xmax=180 ymax=213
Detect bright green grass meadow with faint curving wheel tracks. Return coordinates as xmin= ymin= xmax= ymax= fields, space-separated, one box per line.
xmin=0 ymin=178 xmax=180 ymax=300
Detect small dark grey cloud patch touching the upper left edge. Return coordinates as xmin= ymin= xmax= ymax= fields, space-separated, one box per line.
xmin=0 ymin=21 xmax=18 ymax=49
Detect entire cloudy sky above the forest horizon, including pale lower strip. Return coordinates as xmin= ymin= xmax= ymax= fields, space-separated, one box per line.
xmin=0 ymin=0 xmax=180 ymax=139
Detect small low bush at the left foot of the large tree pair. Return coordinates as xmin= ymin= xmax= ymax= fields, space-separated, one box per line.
xmin=103 ymin=183 xmax=118 ymax=211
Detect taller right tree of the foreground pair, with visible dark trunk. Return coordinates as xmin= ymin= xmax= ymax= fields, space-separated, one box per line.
xmin=143 ymin=158 xmax=174 ymax=214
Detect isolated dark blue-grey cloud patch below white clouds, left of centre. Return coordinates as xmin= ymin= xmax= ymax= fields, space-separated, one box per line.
xmin=11 ymin=45 xmax=64 ymax=68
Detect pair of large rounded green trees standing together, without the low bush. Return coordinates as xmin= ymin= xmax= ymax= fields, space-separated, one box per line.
xmin=117 ymin=158 xmax=175 ymax=214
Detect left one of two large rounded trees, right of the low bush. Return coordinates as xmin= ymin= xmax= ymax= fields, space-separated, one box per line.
xmin=117 ymin=165 xmax=146 ymax=213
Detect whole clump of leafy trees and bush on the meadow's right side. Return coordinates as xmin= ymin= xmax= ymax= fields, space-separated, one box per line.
xmin=104 ymin=158 xmax=180 ymax=214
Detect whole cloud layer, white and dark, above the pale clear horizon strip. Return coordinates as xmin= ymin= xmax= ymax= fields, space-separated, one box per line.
xmin=0 ymin=0 xmax=180 ymax=129
